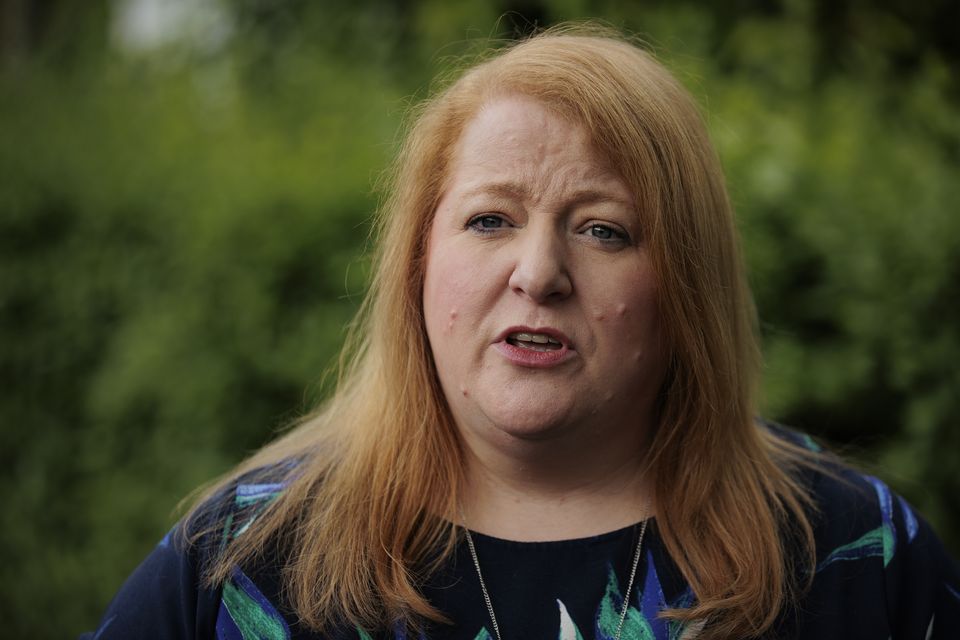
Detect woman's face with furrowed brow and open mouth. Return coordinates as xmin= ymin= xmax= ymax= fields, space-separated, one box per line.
xmin=423 ymin=96 xmax=666 ymax=448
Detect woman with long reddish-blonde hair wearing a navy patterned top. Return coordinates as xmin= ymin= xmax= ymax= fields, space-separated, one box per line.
xmin=86 ymin=22 xmax=960 ymax=640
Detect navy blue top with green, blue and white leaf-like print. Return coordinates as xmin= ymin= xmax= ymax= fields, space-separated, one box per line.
xmin=81 ymin=438 xmax=960 ymax=640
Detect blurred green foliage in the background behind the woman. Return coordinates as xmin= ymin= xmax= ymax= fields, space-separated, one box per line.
xmin=0 ymin=0 xmax=960 ymax=638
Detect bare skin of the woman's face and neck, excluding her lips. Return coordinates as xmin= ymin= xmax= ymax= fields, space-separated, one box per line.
xmin=423 ymin=96 xmax=666 ymax=539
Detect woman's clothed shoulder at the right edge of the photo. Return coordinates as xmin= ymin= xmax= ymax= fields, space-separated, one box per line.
xmin=765 ymin=425 xmax=960 ymax=638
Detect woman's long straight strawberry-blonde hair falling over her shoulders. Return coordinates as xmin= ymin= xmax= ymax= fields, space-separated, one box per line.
xmin=194 ymin=26 xmax=813 ymax=637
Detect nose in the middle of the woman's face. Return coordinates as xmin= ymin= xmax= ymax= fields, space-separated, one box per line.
xmin=509 ymin=225 xmax=573 ymax=303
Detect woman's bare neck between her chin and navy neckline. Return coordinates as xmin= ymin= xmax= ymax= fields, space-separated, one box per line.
xmin=461 ymin=416 xmax=652 ymax=541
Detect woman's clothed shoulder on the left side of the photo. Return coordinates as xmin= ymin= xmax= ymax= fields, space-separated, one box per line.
xmin=80 ymin=466 xmax=300 ymax=640
